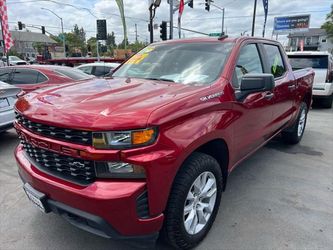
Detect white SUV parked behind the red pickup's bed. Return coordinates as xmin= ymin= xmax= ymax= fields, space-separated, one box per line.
xmin=287 ymin=51 xmax=333 ymax=108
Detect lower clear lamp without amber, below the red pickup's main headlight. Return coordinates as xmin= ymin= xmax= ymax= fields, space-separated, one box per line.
xmin=95 ymin=162 xmax=146 ymax=178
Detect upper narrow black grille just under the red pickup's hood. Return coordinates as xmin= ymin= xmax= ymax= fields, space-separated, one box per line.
xmin=16 ymin=112 xmax=92 ymax=146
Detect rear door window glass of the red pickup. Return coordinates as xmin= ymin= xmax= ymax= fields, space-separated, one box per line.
xmin=264 ymin=44 xmax=286 ymax=78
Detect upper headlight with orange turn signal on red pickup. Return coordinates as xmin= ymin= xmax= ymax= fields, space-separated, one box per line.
xmin=93 ymin=128 xmax=157 ymax=149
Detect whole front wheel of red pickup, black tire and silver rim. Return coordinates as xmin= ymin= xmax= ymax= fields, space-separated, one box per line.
xmin=163 ymin=153 xmax=223 ymax=249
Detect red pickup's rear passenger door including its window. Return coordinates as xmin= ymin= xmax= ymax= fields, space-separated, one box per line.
xmin=262 ymin=43 xmax=297 ymax=131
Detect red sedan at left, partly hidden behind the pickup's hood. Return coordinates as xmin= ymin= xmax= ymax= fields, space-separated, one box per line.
xmin=0 ymin=65 xmax=93 ymax=93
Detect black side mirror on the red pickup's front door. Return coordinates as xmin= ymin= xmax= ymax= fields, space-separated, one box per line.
xmin=236 ymin=74 xmax=275 ymax=100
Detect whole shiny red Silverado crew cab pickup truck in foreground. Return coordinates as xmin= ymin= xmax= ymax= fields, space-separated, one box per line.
xmin=15 ymin=37 xmax=314 ymax=249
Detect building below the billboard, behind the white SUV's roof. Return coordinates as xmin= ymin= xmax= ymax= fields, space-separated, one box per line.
xmin=286 ymin=28 xmax=333 ymax=53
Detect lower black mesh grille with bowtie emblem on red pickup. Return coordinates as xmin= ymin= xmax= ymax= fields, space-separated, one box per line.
xmin=21 ymin=140 xmax=96 ymax=185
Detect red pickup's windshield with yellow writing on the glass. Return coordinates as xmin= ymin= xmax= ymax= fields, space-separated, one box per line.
xmin=113 ymin=42 xmax=233 ymax=84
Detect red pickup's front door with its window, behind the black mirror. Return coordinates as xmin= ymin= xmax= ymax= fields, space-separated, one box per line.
xmin=232 ymin=43 xmax=274 ymax=163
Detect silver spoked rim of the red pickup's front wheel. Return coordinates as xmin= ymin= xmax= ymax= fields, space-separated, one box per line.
xmin=183 ymin=172 xmax=217 ymax=235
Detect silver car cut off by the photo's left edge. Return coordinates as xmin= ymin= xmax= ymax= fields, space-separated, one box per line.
xmin=0 ymin=81 xmax=21 ymax=132
